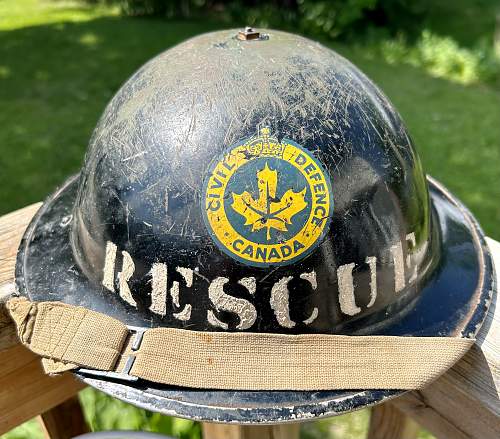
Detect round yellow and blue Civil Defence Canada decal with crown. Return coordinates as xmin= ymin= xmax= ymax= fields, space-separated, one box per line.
xmin=202 ymin=128 xmax=333 ymax=267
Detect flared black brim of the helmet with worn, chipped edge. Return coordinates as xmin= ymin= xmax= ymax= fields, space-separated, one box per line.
xmin=16 ymin=176 xmax=495 ymax=424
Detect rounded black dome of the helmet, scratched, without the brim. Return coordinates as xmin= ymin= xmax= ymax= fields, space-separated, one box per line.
xmin=71 ymin=30 xmax=432 ymax=333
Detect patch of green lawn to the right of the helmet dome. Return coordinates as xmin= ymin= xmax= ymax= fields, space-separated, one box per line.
xmin=339 ymin=47 xmax=500 ymax=240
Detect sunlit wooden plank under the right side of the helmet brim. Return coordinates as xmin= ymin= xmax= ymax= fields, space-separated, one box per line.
xmin=393 ymin=239 xmax=500 ymax=439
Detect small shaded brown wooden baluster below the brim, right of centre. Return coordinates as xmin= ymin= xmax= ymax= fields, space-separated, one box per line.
xmin=367 ymin=402 xmax=419 ymax=439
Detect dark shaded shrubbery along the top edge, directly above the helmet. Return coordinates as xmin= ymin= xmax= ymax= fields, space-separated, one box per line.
xmin=86 ymin=0 xmax=429 ymax=38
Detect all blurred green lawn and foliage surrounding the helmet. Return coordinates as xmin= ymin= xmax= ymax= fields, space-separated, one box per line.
xmin=0 ymin=0 xmax=500 ymax=439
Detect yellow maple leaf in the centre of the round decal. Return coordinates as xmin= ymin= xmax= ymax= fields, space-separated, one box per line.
xmin=231 ymin=162 xmax=307 ymax=241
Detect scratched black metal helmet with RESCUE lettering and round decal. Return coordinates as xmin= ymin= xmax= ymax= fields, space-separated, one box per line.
xmin=16 ymin=26 xmax=493 ymax=423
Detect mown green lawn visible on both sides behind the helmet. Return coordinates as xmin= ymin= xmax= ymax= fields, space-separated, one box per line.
xmin=0 ymin=0 xmax=500 ymax=439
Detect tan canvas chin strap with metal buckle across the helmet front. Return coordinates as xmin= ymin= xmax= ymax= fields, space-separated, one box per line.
xmin=7 ymin=298 xmax=474 ymax=390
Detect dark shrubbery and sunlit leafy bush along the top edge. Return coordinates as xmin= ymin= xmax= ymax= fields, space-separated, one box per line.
xmin=88 ymin=0 xmax=500 ymax=83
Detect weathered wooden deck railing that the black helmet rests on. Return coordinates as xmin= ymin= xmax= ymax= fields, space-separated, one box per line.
xmin=0 ymin=203 xmax=500 ymax=439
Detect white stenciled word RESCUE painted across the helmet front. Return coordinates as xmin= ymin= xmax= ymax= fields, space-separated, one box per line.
xmin=101 ymin=232 xmax=420 ymax=330
